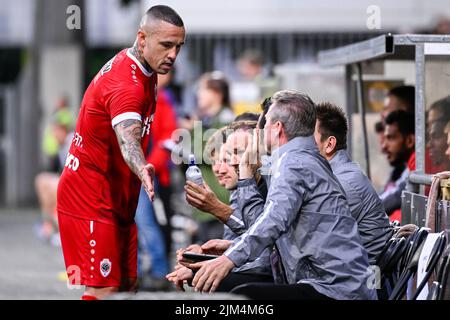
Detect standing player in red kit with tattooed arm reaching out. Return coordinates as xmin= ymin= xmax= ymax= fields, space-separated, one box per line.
xmin=57 ymin=6 xmax=185 ymax=300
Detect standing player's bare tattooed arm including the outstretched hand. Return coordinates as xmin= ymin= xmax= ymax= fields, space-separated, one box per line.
xmin=114 ymin=119 xmax=155 ymax=200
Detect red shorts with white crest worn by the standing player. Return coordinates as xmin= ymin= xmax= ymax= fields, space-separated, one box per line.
xmin=58 ymin=213 xmax=138 ymax=287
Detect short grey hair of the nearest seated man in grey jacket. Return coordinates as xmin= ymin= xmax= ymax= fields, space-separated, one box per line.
xmin=270 ymin=90 xmax=316 ymax=140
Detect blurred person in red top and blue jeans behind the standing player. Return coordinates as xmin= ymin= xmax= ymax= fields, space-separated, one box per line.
xmin=135 ymin=72 xmax=176 ymax=291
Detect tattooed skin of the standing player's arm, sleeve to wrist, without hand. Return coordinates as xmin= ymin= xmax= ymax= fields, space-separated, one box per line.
xmin=114 ymin=120 xmax=147 ymax=180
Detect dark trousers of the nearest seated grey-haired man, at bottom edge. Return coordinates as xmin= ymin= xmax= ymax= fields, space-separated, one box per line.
xmin=231 ymin=283 xmax=333 ymax=300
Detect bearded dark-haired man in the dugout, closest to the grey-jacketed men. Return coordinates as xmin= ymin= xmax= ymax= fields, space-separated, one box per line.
xmin=380 ymin=110 xmax=415 ymax=221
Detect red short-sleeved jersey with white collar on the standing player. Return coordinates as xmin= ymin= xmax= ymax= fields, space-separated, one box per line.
xmin=57 ymin=49 xmax=157 ymax=224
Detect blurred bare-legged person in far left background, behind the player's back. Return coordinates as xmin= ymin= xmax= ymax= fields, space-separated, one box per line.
xmin=34 ymin=108 xmax=73 ymax=245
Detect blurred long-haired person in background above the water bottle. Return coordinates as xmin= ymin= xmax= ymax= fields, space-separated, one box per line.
xmin=180 ymin=71 xmax=234 ymax=243
